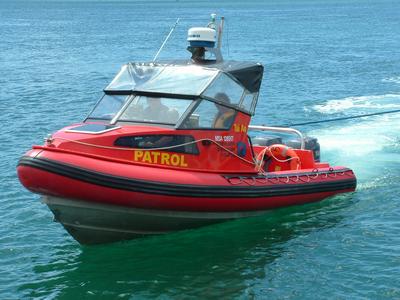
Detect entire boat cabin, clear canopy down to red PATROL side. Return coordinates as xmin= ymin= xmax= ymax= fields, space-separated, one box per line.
xmin=61 ymin=60 xmax=263 ymax=172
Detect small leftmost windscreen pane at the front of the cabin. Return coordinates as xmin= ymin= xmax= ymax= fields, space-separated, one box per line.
xmin=88 ymin=94 xmax=129 ymax=120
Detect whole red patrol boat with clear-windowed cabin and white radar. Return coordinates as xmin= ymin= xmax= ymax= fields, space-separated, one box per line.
xmin=18 ymin=15 xmax=356 ymax=244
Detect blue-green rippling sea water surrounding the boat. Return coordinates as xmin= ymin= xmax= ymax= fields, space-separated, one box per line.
xmin=0 ymin=0 xmax=400 ymax=299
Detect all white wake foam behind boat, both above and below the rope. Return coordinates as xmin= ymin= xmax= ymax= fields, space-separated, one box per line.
xmin=308 ymin=94 xmax=400 ymax=176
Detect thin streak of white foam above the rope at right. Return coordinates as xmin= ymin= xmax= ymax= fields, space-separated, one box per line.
xmin=312 ymin=94 xmax=400 ymax=114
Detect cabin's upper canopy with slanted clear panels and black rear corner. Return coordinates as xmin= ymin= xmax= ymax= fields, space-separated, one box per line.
xmin=105 ymin=60 xmax=263 ymax=115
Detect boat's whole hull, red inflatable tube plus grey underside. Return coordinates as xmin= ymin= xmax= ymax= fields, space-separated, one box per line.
xmin=17 ymin=152 xmax=356 ymax=244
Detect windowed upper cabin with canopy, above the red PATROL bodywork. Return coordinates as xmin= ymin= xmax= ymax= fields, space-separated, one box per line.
xmin=86 ymin=61 xmax=263 ymax=130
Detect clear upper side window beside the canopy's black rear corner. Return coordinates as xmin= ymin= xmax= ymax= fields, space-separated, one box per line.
xmin=203 ymin=73 xmax=244 ymax=105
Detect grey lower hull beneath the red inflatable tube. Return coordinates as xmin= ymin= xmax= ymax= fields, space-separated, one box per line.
xmin=42 ymin=196 xmax=265 ymax=245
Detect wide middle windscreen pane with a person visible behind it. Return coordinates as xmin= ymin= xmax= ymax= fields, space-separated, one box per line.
xmin=118 ymin=96 xmax=193 ymax=124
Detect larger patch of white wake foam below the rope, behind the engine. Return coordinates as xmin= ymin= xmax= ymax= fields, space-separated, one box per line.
xmin=308 ymin=116 xmax=400 ymax=182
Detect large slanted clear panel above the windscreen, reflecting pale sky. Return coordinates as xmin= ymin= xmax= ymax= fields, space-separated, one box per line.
xmin=105 ymin=64 xmax=219 ymax=96
